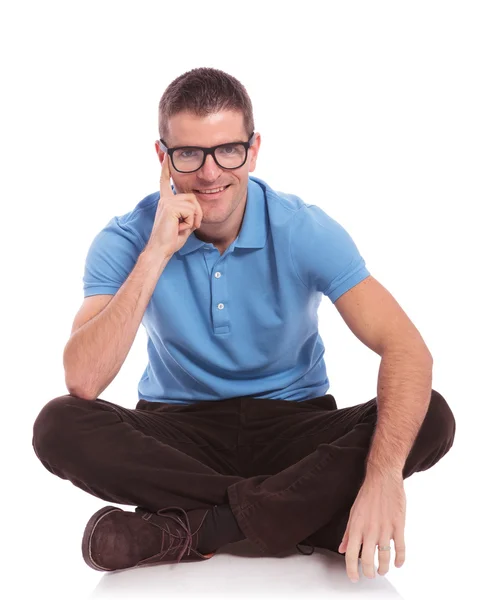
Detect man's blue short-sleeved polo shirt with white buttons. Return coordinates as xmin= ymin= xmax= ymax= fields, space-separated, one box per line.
xmin=83 ymin=176 xmax=369 ymax=404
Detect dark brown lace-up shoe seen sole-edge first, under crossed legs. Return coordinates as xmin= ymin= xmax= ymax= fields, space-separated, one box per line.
xmin=82 ymin=506 xmax=215 ymax=571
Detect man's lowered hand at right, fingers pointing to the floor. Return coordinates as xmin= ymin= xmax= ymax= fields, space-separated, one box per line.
xmin=339 ymin=473 xmax=406 ymax=582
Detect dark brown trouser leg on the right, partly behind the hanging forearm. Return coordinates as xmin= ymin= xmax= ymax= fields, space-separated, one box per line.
xmin=228 ymin=390 xmax=455 ymax=553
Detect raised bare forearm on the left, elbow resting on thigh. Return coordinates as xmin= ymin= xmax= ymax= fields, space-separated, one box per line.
xmin=64 ymin=250 xmax=169 ymax=400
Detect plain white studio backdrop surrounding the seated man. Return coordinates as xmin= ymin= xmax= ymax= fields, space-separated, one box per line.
xmin=0 ymin=0 xmax=483 ymax=598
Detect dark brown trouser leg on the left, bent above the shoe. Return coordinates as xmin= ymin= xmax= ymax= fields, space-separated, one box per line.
xmin=32 ymin=395 xmax=246 ymax=512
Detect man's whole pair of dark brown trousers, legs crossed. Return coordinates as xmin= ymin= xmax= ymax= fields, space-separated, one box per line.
xmin=32 ymin=390 xmax=455 ymax=554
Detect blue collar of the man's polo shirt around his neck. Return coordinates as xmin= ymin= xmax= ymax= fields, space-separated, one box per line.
xmin=178 ymin=177 xmax=268 ymax=256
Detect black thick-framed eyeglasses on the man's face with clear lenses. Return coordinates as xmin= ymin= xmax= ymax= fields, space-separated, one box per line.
xmin=159 ymin=132 xmax=255 ymax=173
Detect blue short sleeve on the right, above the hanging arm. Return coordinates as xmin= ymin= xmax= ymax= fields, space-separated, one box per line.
xmin=289 ymin=204 xmax=370 ymax=302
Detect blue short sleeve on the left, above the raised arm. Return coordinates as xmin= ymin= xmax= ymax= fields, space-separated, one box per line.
xmin=83 ymin=217 xmax=141 ymax=297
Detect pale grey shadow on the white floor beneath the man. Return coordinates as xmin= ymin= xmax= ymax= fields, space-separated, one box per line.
xmin=90 ymin=540 xmax=402 ymax=600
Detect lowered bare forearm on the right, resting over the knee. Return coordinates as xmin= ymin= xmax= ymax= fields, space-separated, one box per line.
xmin=366 ymin=344 xmax=432 ymax=477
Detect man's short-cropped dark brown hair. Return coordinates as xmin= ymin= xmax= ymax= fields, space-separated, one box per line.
xmin=158 ymin=67 xmax=255 ymax=138
